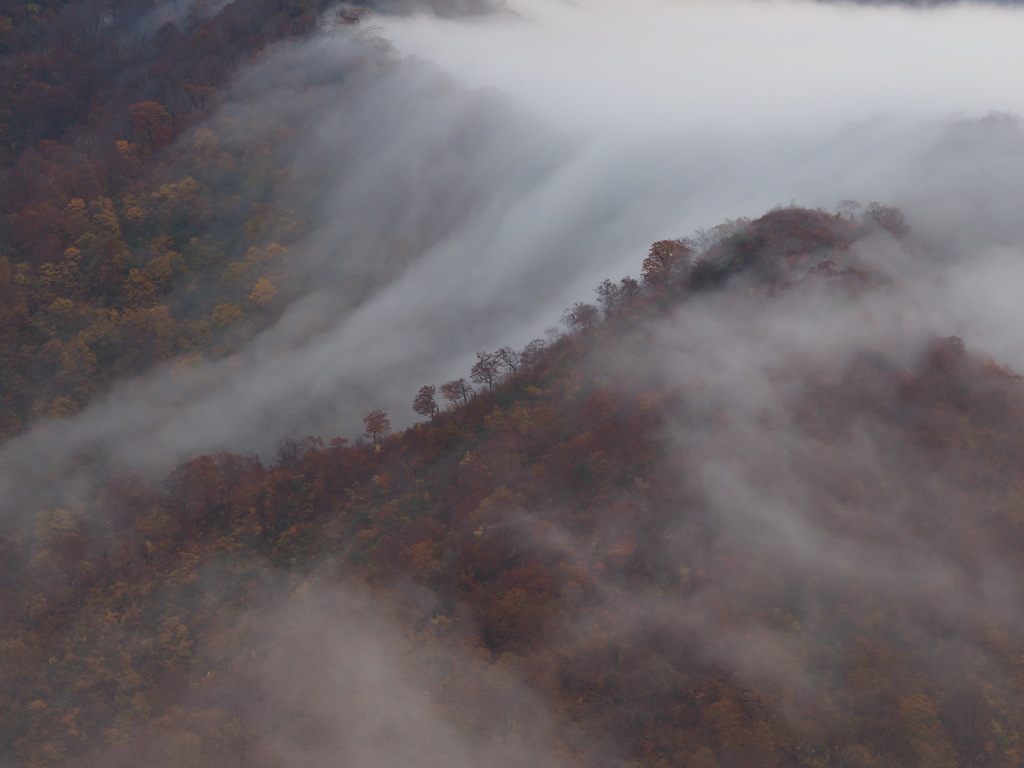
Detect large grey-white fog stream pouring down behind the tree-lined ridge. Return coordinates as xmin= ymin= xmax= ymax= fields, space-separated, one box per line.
xmin=9 ymin=0 xmax=1024 ymax=518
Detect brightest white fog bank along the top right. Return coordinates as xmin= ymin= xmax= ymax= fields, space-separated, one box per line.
xmin=381 ymin=0 xmax=1021 ymax=139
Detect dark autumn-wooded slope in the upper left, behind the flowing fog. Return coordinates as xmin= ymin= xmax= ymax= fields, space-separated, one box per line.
xmin=0 ymin=0 xmax=364 ymax=436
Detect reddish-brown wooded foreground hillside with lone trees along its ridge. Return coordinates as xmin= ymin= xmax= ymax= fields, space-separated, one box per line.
xmin=6 ymin=199 xmax=1024 ymax=766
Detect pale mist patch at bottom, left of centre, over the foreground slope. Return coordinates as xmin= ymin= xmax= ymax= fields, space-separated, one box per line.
xmin=196 ymin=584 xmax=585 ymax=768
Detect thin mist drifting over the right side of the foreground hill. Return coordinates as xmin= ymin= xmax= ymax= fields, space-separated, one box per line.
xmin=569 ymin=247 xmax=1024 ymax=765
